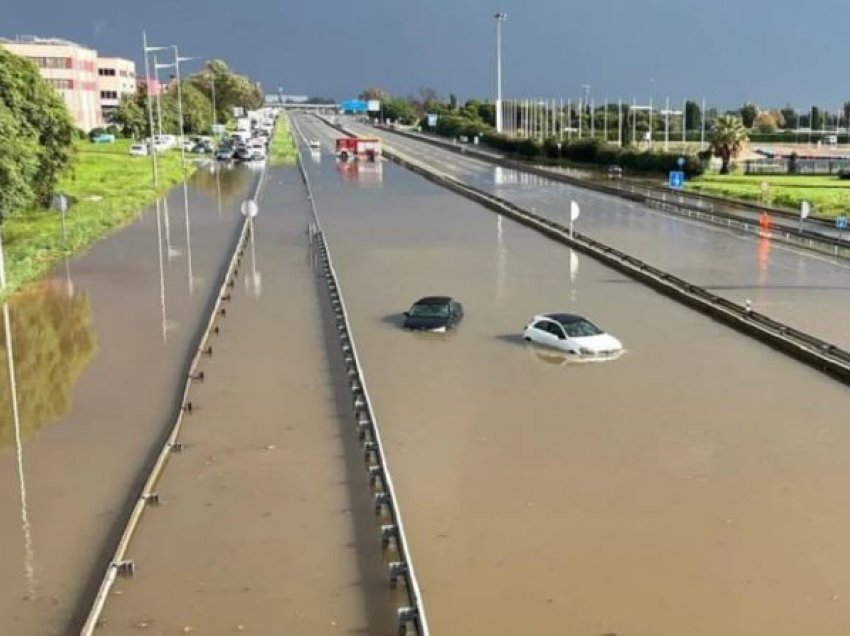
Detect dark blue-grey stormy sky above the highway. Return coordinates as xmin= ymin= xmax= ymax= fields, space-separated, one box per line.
xmin=0 ymin=0 xmax=850 ymax=108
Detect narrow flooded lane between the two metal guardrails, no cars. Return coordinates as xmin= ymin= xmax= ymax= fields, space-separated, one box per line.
xmin=100 ymin=168 xmax=397 ymax=636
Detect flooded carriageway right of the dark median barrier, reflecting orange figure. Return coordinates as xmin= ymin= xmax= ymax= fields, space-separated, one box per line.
xmin=342 ymin=119 xmax=850 ymax=349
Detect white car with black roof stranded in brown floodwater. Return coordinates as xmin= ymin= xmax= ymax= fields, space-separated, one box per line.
xmin=522 ymin=314 xmax=623 ymax=356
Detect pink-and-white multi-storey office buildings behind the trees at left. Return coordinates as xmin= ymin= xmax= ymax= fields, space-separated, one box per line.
xmin=0 ymin=36 xmax=136 ymax=131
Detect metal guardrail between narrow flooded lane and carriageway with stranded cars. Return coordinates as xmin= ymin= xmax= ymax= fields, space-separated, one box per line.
xmin=289 ymin=114 xmax=430 ymax=636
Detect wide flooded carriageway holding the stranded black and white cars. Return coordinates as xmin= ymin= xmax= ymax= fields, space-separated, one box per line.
xmin=294 ymin=114 xmax=850 ymax=636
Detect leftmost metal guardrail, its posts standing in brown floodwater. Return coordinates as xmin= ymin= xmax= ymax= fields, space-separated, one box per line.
xmin=80 ymin=168 xmax=265 ymax=636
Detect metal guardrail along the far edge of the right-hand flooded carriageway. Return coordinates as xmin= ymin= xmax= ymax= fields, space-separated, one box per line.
xmin=383 ymin=128 xmax=850 ymax=250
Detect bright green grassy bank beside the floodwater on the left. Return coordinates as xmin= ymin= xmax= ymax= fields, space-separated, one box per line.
xmin=3 ymin=139 xmax=193 ymax=294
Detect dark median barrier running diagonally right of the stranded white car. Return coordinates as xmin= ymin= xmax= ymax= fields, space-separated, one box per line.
xmin=322 ymin=120 xmax=850 ymax=384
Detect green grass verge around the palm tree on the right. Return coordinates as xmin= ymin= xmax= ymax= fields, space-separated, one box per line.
xmin=686 ymin=174 xmax=850 ymax=219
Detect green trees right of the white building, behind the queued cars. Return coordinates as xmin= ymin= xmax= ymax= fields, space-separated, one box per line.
xmin=110 ymin=60 xmax=263 ymax=138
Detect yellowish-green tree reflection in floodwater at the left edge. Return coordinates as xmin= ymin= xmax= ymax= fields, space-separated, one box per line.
xmin=0 ymin=283 xmax=97 ymax=448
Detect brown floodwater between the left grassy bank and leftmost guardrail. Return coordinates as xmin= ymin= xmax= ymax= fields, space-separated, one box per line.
xmin=0 ymin=163 xmax=255 ymax=636
